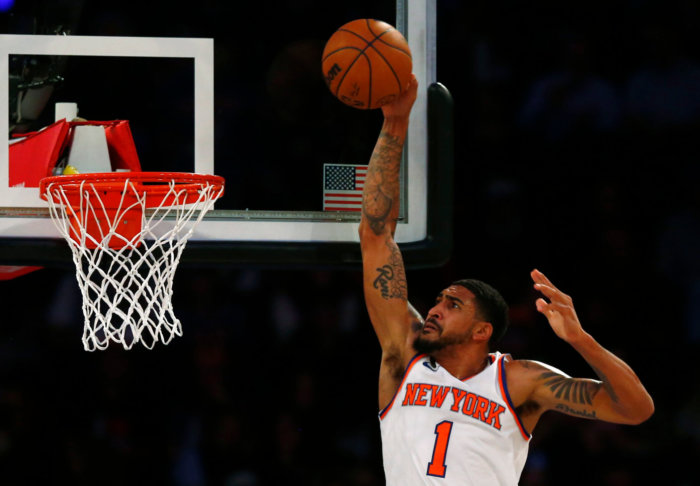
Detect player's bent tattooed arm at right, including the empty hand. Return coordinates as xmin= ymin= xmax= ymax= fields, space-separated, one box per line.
xmin=530 ymin=270 xmax=654 ymax=424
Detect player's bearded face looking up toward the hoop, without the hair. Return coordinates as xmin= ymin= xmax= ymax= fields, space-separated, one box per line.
xmin=414 ymin=285 xmax=476 ymax=352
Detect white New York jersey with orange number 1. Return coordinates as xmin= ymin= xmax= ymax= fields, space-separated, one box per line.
xmin=379 ymin=353 xmax=531 ymax=486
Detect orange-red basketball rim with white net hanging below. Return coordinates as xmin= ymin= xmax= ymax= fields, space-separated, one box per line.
xmin=39 ymin=172 xmax=224 ymax=351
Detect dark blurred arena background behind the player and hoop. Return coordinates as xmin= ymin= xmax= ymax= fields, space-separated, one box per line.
xmin=0 ymin=0 xmax=700 ymax=486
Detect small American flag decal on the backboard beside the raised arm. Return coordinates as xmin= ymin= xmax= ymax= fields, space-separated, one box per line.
xmin=323 ymin=164 xmax=367 ymax=212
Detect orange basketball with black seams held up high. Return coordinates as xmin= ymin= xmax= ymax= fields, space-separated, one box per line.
xmin=321 ymin=19 xmax=413 ymax=110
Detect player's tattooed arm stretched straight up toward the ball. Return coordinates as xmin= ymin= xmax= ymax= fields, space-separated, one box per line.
xmin=359 ymin=76 xmax=418 ymax=361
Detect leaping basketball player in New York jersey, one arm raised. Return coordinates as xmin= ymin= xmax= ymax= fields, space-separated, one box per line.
xmin=359 ymin=77 xmax=654 ymax=486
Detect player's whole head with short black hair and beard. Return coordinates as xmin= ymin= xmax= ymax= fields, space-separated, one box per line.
xmin=414 ymin=279 xmax=508 ymax=354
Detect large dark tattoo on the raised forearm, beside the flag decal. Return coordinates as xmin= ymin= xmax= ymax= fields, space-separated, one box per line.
xmin=362 ymin=132 xmax=403 ymax=234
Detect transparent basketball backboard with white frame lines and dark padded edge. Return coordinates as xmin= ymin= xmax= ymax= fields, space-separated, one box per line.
xmin=0 ymin=0 xmax=452 ymax=266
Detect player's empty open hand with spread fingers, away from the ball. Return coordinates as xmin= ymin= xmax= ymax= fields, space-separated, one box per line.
xmin=530 ymin=270 xmax=585 ymax=343
